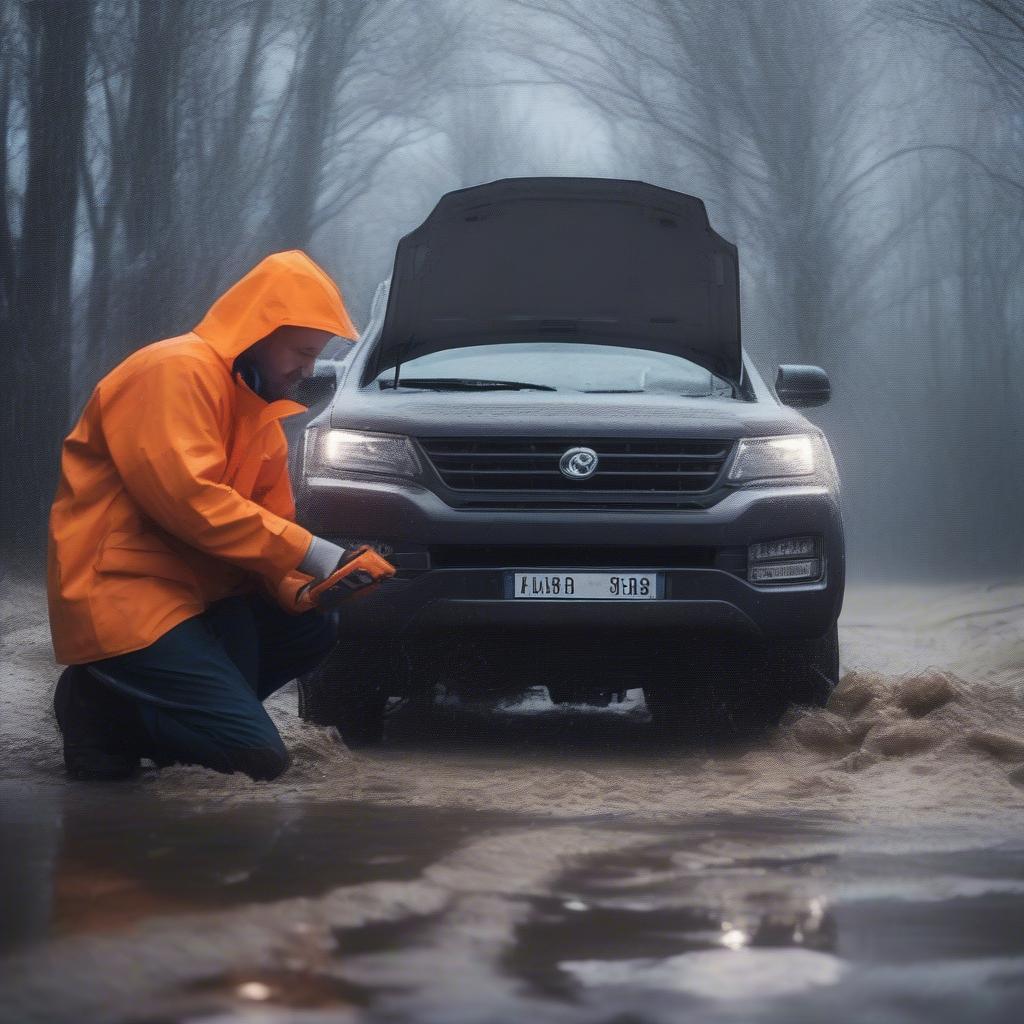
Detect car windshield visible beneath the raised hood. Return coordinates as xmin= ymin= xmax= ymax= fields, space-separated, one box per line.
xmin=377 ymin=341 xmax=733 ymax=398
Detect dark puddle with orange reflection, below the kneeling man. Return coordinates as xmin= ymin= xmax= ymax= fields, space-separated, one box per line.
xmin=0 ymin=785 xmax=516 ymax=950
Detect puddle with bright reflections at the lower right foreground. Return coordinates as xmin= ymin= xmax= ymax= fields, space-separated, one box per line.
xmin=502 ymin=819 xmax=1024 ymax=1021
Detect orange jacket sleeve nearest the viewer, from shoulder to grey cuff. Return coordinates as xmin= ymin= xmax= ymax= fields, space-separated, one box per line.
xmin=99 ymin=356 xmax=312 ymax=582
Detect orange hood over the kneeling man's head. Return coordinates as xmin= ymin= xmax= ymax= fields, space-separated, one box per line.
xmin=195 ymin=249 xmax=359 ymax=367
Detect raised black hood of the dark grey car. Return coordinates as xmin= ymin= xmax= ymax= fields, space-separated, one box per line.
xmin=367 ymin=177 xmax=742 ymax=384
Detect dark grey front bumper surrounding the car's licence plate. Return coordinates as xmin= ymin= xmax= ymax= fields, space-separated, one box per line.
xmin=297 ymin=475 xmax=845 ymax=641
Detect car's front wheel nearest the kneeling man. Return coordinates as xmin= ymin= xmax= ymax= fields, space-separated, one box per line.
xmin=298 ymin=640 xmax=406 ymax=749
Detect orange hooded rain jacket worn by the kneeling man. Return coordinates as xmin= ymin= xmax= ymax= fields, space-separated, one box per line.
xmin=47 ymin=250 xmax=358 ymax=665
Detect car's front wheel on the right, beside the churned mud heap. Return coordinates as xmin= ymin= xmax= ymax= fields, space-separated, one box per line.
xmin=644 ymin=626 xmax=839 ymax=740
